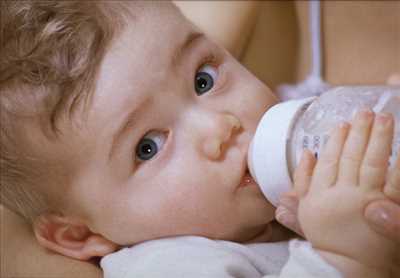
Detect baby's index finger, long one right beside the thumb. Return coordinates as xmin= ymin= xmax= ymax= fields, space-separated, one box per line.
xmin=311 ymin=122 xmax=350 ymax=187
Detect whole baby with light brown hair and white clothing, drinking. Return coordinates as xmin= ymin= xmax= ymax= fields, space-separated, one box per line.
xmin=0 ymin=1 xmax=400 ymax=277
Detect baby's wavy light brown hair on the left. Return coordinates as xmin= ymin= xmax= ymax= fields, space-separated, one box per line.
xmin=0 ymin=1 xmax=138 ymax=222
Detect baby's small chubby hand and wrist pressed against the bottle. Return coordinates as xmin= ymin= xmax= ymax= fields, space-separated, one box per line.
xmin=284 ymin=111 xmax=400 ymax=274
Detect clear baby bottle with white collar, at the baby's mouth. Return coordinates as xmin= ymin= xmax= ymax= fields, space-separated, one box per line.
xmin=248 ymin=86 xmax=400 ymax=206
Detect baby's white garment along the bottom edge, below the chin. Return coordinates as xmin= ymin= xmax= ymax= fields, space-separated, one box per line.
xmin=100 ymin=236 xmax=342 ymax=278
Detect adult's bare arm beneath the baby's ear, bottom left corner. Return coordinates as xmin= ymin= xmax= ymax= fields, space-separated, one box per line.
xmin=0 ymin=205 xmax=103 ymax=278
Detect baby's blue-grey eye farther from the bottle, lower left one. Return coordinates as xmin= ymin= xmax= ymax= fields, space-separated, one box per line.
xmin=136 ymin=131 xmax=166 ymax=161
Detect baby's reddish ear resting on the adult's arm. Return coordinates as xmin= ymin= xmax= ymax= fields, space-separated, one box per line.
xmin=33 ymin=214 xmax=118 ymax=260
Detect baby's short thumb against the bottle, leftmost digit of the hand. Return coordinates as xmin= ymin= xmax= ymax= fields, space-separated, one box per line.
xmin=294 ymin=149 xmax=316 ymax=198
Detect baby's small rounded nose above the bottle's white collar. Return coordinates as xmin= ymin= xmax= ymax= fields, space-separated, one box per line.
xmin=202 ymin=114 xmax=241 ymax=160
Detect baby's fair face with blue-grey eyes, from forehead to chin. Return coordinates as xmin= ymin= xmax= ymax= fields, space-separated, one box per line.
xmin=59 ymin=3 xmax=277 ymax=245
